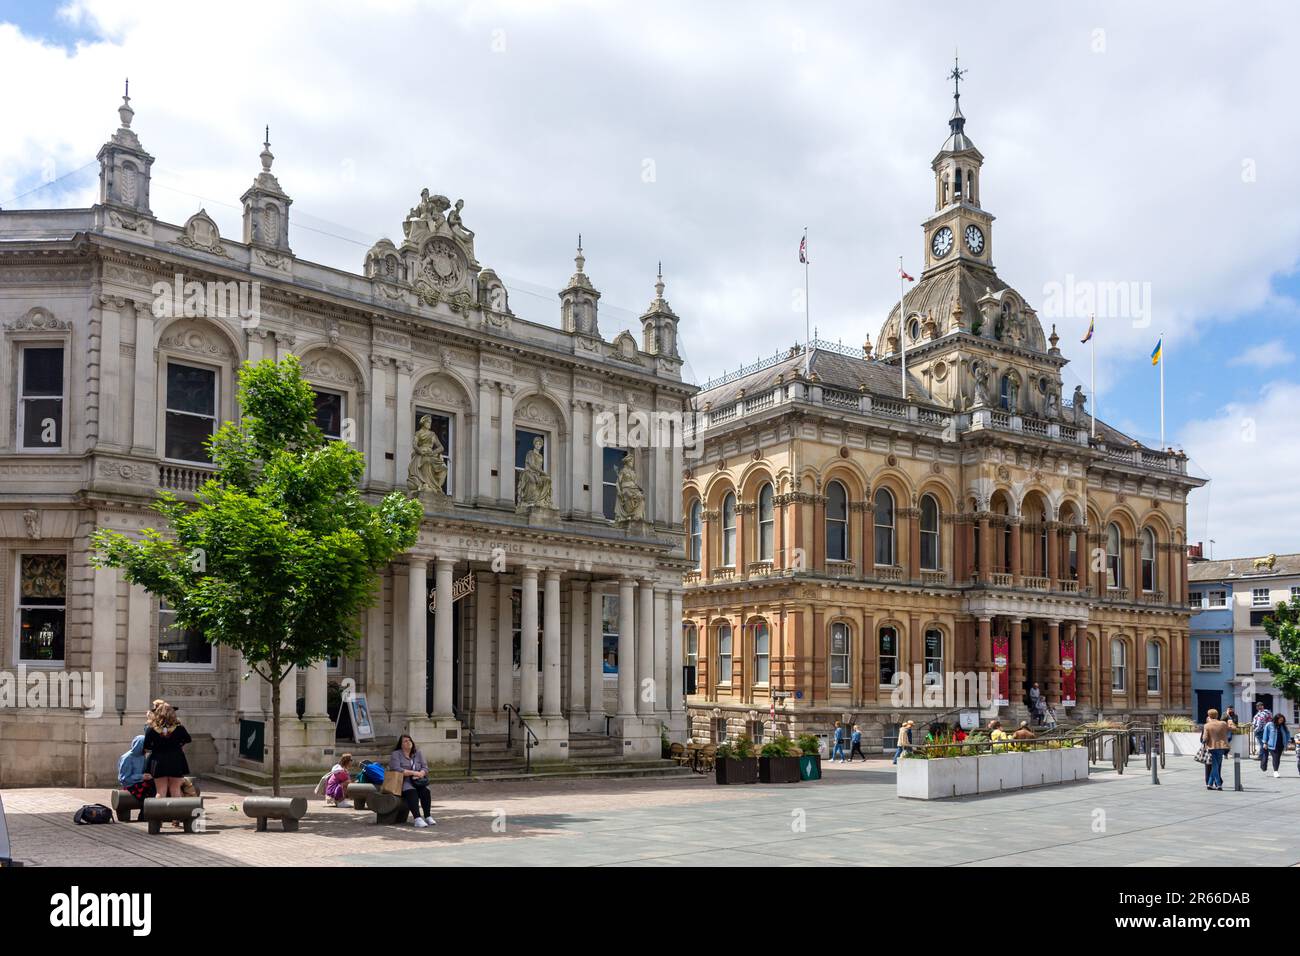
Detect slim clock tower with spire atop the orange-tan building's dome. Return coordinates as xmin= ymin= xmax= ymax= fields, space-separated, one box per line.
xmin=922 ymin=60 xmax=993 ymax=272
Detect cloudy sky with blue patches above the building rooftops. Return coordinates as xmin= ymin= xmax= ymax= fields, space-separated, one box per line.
xmin=0 ymin=0 xmax=1300 ymax=557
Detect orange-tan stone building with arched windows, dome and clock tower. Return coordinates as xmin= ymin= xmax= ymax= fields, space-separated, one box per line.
xmin=684 ymin=89 xmax=1204 ymax=749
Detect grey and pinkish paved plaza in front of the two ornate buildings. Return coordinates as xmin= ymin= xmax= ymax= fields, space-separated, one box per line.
xmin=4 ymin=757 xmax=1300 ymax=866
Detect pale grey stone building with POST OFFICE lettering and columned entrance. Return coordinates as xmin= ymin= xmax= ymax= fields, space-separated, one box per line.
xmin=0 ymin=98 xmax=694 ymax=786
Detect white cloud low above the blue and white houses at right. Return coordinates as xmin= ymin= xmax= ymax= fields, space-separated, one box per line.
xmin=1182 ymin=381 xmax=1300 ymax=558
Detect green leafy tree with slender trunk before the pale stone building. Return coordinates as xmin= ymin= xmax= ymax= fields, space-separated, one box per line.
xmin=92 ymin=355 xmax=423 ymax=795
